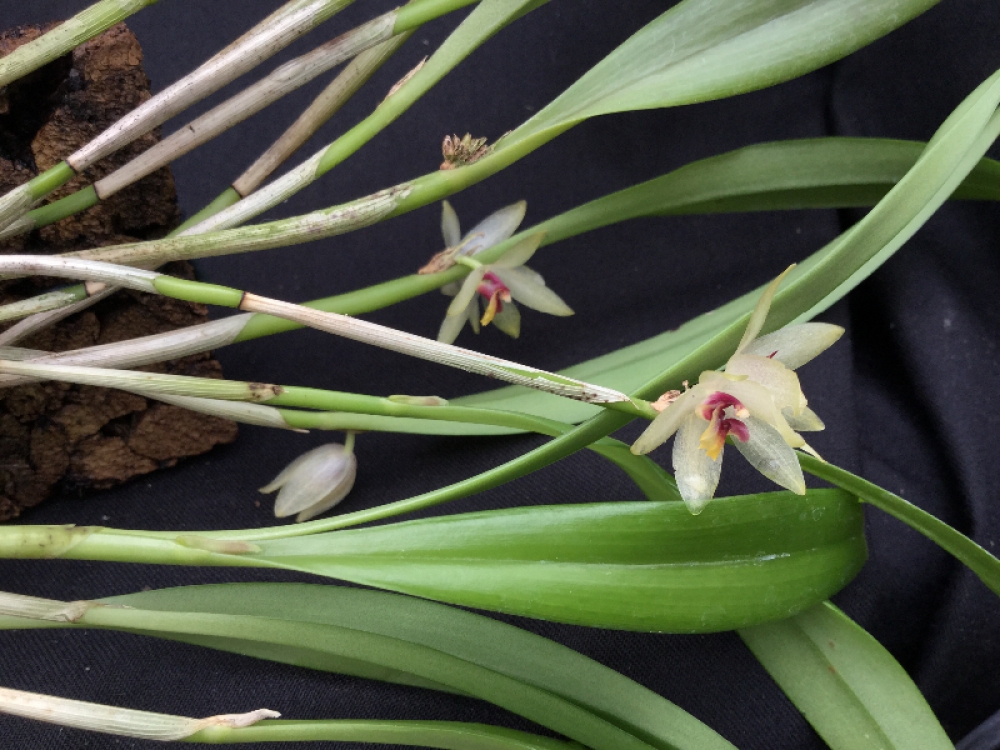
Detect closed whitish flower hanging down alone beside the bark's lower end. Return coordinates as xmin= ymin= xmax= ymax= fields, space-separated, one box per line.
xmin=260 ymin=433 xmax=358 ymax=523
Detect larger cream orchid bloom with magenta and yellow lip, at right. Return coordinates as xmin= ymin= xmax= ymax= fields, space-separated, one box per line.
xmin=632 ymin=269 xmax=844 ymax=513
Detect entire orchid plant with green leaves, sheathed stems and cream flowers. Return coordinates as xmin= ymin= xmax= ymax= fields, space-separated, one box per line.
xmin=0 ymin=0 xmax=1000 ymax=750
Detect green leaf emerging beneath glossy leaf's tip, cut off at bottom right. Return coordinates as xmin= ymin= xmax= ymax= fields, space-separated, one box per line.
xmin=740 ymin=602 xmax=954 ymax=750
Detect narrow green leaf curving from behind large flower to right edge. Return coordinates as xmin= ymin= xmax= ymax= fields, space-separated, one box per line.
xmin=799 ymin=454 xmax=1000 ymax=596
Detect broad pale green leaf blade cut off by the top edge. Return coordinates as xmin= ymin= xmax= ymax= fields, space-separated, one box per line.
xmin=500 ymin=0 xmax=936 ymax=148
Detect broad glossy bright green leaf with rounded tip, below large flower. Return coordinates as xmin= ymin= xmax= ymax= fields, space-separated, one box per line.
xmin=244 ymin=490 xmax=865 ymax=632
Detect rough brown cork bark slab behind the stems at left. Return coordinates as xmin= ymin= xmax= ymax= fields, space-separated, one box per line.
xmin=0 ymin=24 xmax=236 ymax=520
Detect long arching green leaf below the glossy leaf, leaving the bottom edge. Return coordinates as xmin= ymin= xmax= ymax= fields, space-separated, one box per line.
xmin=0 ymin=583 xmax=733 ymax=750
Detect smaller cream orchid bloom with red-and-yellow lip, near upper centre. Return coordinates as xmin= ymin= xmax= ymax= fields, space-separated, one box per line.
xmin=438 ymin=201 xmax=573 ymax=344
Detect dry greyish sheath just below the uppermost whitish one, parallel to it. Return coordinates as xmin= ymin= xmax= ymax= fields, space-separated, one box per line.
xmin=94 ymin=13 xmax=395 ymax=200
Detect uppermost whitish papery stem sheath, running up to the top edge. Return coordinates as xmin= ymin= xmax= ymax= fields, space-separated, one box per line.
xmin=66 ymin=0 xmax=360 ymax=172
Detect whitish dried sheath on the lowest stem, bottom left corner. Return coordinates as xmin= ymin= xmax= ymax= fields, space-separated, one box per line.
xmin=0 ymin=688 xmax=281 ymax=742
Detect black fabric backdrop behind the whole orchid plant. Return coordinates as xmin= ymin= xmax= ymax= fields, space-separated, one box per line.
xmin=0 ymin=0 xmax=1000 ymax=750
